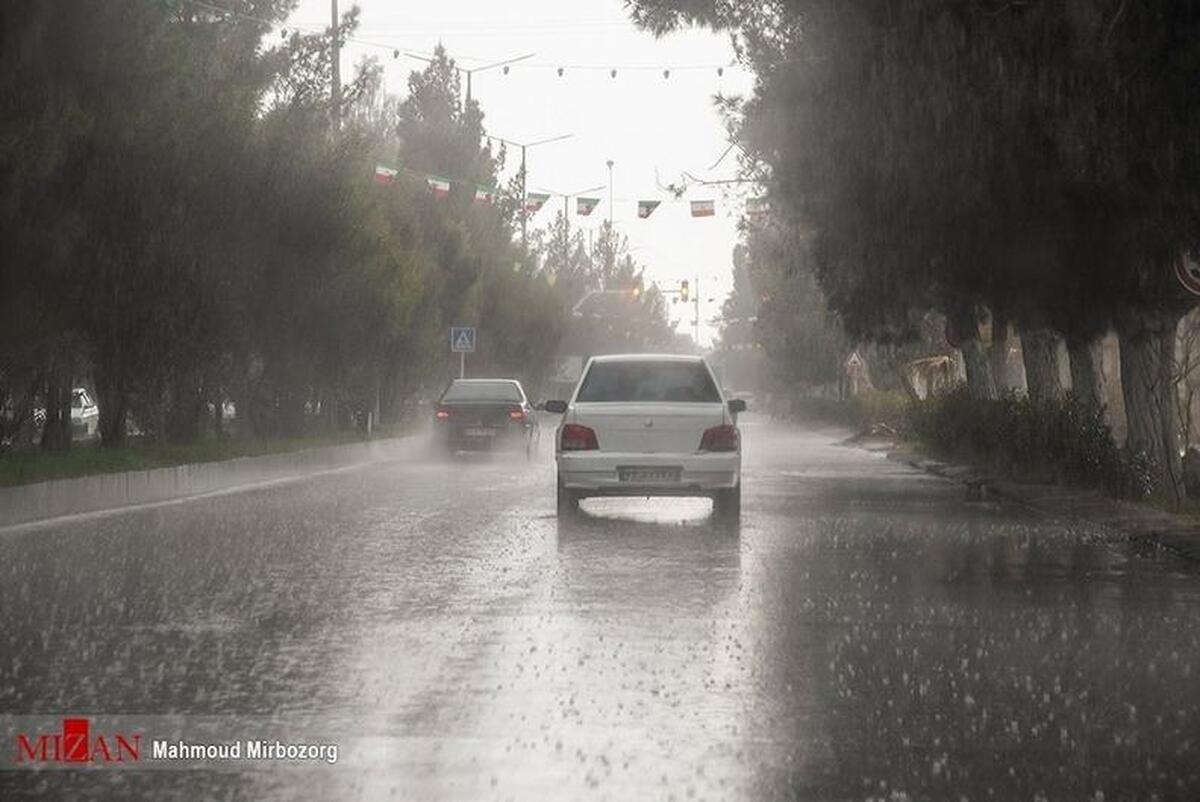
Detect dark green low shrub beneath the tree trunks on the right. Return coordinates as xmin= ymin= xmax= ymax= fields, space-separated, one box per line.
xmin=907 ymin=390 xmax=1154 ymax=498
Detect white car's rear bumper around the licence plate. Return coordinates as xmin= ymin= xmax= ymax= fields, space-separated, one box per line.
xmin=558 ymin=451 xmax=742 ymax=496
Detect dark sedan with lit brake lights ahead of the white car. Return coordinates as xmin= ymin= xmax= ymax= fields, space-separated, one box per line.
xmin=433 ymin=378 xmax=539 ymax=457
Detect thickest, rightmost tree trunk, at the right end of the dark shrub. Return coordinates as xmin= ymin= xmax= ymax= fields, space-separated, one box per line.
xmin=1118 ymin=312 xmax=1184 ymax=504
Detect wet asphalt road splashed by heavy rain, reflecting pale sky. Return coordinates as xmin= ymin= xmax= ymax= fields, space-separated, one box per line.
xmin=0 ymin=419 xmax=1200 ymax=802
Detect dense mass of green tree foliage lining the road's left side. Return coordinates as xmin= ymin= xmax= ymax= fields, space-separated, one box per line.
xmin=0 ymin=0 xmax=565 ymax=445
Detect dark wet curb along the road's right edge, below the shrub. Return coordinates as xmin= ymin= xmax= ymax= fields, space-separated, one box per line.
xmin=873 ymin=443 xmax=1200 ymax=562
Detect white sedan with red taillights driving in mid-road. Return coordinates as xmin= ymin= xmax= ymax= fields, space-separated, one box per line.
xmin=544 ymin=354 xmax=745 ymax=517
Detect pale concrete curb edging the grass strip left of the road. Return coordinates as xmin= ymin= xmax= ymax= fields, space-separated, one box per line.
xmin=0 ymin=436 xmax=413 ymax=528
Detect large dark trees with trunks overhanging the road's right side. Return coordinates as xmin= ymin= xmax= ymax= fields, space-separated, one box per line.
xmin=632 ymin=0 xmax=1200 ymax=499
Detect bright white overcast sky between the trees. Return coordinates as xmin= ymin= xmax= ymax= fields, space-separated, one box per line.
xmin=289 ymin=0 xmax=755 ymax=342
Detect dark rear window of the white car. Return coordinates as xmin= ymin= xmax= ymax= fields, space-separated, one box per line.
xmin=576 ymin=360 xmax=721 ymax=403
